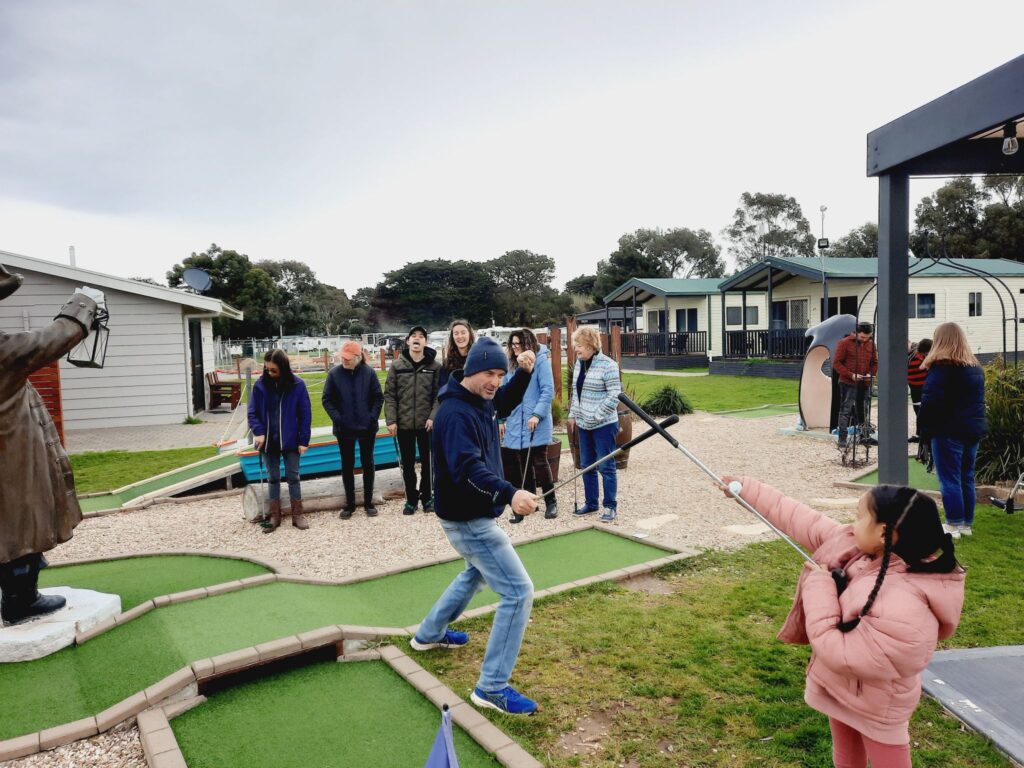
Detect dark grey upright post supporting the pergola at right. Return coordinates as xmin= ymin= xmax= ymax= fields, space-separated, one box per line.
xmin=874 ymin=174 xmax=910 ymax=485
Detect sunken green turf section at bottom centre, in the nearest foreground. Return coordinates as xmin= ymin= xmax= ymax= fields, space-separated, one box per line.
xmin=171 ymin=662 xmax=499 ymax=768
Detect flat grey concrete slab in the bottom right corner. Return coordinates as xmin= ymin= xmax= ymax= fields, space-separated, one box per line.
xmin=921 ymin=645 xmax=1024 ymax=764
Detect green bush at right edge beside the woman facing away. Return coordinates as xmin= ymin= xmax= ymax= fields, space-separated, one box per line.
xmin=975 ymin=359 xmax=1024 ymax=484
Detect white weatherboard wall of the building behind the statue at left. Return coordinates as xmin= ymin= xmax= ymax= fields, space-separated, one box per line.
xmin=0 ymin=268 xmax=192 ymax=429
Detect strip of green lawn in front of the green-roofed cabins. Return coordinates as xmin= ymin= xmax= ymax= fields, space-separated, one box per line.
xmin=623 ymin=373 xmax=799 ymax=412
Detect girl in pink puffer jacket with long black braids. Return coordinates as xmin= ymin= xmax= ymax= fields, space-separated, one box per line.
xmin=725 ymin=477 xmax=964 ymax=768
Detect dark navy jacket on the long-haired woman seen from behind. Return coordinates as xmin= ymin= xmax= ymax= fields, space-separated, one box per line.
xmin=918 ymin=362 xmax=988 ymax=443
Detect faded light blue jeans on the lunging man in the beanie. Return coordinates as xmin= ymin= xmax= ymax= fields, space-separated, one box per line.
xmin=416 ymin=517 xmax=534 ymax=692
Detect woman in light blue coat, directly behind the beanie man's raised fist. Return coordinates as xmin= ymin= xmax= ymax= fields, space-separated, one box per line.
xmin=503 ymin=328 xmax=558 ymax=522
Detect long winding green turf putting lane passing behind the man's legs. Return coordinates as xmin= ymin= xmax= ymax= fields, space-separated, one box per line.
xmin=0 ymin=529 xmax=665 ymax=739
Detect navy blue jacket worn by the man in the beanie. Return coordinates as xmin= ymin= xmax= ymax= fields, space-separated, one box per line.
xmin=431 ymin=370 xmax=530 ymax=522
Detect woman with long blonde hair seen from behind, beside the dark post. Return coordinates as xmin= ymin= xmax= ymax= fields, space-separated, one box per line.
xmin=919 ymin=323 xmax=988 ymax=539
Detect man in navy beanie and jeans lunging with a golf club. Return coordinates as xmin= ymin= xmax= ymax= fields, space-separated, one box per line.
xmin=410 ymin=338 xmax=539 ymax=715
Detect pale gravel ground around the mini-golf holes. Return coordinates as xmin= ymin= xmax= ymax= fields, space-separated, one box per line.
xmin=10 ymin=414 xmax=872 ymax=768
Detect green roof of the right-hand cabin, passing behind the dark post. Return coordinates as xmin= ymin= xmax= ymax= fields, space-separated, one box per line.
xmin=721 ymin=256 xmax=1024 ymax=291
